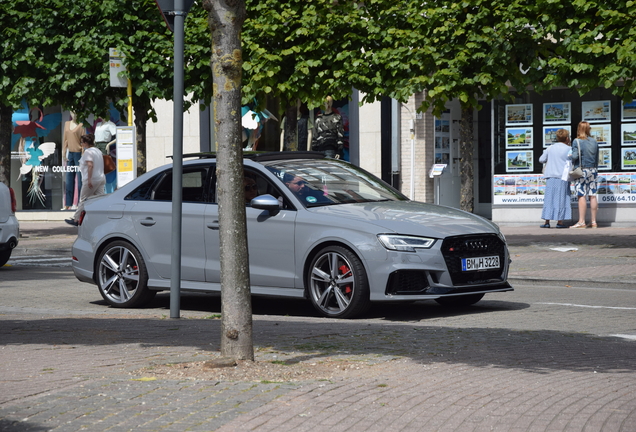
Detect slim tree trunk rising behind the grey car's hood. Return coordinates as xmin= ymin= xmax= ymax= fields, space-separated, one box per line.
xmin=459 ymin=106 xmax=475 ymax=213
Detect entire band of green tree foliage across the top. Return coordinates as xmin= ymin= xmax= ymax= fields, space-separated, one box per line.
xmin=0 ymin=0 xmax=636 ymax=121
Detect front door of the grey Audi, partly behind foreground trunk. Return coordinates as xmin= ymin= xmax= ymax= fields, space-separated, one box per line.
xmin=204 ymin=168 xmax=302 ymax=288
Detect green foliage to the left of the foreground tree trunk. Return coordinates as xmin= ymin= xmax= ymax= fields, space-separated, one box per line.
xmin=0 ymin=0 xmax=211 ymax=118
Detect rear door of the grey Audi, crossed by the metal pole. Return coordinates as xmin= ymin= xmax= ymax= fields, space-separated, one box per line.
xmin=130 ymin=166 xmax=209 ymax=282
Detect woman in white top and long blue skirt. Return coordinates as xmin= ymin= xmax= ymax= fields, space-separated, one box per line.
xmin=539 ymin=129 xmax=572 ymax=228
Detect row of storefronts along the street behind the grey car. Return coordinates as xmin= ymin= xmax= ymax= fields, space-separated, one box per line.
xmin=11 ymin=89 xmax=636 ymax=226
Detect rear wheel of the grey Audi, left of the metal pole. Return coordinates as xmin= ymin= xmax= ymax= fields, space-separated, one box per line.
xmin=95 ymin=241 xmax=157 ymax=308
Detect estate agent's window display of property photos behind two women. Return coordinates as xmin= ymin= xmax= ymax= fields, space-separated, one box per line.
xmin=493 ymin=95 xmax=636 ymax=206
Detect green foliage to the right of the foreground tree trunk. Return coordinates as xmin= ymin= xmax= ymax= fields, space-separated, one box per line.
xmin=243 ymin=0 xmax=636 ymax=113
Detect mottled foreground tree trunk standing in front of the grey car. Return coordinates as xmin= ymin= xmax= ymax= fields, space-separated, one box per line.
xmin=203 ymin=0 xmax=254 ymax=360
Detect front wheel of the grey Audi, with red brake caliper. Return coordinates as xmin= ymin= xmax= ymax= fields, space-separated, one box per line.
xmin=306 ymin=246 xmax=371 ymax=318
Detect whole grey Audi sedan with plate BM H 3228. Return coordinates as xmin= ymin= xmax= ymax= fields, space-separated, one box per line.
xmin=73 ymin=152 xmax=512 ymax=318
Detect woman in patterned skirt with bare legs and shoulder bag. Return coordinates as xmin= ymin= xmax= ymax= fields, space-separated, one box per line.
xmin=570 ymin=121 xmax=598 ymax=228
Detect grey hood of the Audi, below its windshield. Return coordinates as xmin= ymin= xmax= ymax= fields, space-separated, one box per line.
xmin=311 ymin=201 xmax=499 ymax=238
